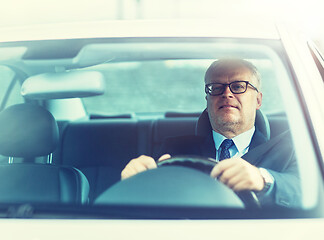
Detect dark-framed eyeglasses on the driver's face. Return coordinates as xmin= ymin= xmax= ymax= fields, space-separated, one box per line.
xmin=205 ymin=81 xmax=259 ymax=96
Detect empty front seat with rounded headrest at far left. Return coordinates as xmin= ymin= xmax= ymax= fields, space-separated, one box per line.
xmin=0 ymin=104 xmax=89 ymax=204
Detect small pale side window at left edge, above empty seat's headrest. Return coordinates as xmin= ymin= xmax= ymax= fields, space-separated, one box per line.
xmin=0 ymin=66 xmax=24 ymax=111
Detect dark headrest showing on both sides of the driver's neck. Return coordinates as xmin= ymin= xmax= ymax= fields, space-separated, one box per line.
xmin=196 ymin=109 xmax=270 ymax=140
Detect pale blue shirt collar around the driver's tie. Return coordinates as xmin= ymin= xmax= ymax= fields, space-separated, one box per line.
xmin=213 ymin=126 xmax=255 ymax=152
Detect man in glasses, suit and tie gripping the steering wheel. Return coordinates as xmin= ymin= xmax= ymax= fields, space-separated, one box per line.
xmin=121 ymin=59 xmax=300 ymax=207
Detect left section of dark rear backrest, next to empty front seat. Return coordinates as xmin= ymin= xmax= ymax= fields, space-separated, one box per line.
xmin=53 ymin=119 xmax=142 ymax=201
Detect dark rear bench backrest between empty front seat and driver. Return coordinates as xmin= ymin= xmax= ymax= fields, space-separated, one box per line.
xmin=53 ymin=117 xmax=197 ymax=202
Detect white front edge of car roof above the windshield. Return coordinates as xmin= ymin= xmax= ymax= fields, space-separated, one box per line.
xmin=0 ymin=18 xmax=280 ymax=42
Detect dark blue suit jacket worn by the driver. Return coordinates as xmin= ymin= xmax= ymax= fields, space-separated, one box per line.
xmin=161 ymin=111 xmax=301 ymax=207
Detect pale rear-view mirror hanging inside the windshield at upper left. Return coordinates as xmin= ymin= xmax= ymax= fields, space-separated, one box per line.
xmin=21 ymin=71 xmax=105 ymax=99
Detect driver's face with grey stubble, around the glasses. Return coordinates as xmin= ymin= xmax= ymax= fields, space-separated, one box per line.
xmin=206 ymin=67 xmax=262 ymax=138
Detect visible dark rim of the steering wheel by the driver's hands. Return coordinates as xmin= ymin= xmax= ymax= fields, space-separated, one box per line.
xmin=157 ymin=155 xmax=261 ymax=208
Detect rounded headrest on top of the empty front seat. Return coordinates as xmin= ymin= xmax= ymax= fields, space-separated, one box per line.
xmin=0 ymin=104 xmax=59 ymax=158
